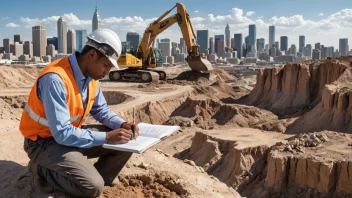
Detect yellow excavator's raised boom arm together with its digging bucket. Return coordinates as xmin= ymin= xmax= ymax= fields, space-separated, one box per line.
xmin=138 ymin=3 xmax=213 ymax=71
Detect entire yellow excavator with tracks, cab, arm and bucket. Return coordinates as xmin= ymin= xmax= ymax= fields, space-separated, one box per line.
xmin=109 ymin=3 xmax=213 ymax=82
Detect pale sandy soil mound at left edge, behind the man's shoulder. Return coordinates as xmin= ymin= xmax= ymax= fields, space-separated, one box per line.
xmin=0 ymin=66 xmax=40 ymax=88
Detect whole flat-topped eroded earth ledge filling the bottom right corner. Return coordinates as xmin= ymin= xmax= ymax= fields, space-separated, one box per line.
xmin=180 ymin=131 xmax=352 ymax=197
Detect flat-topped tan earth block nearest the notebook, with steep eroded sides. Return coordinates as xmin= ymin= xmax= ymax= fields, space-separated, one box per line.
xmin=181 ymin=129 xmax=284 ymax=192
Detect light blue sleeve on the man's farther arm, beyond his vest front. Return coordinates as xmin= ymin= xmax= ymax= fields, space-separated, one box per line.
xmin=90 ymin=84 xmax=125 ymax=129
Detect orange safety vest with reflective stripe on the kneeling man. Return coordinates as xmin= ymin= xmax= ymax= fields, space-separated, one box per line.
xmin=19 ymin=57 xmax=98 ymax=141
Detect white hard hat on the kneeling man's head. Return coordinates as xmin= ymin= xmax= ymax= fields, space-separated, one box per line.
xmin=86 ymin=29 xmax=122 ymax=68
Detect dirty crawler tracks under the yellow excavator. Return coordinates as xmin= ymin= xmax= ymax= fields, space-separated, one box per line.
xmin=109 ymin=69 xmax=166 ymax=82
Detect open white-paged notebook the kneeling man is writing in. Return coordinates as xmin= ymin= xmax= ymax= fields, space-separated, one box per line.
xmin=103 ymin=123 xmax=180 ymax=153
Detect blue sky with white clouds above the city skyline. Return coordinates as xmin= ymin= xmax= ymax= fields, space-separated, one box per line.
xmin=0 ymin=0 xmax=352 ymax=49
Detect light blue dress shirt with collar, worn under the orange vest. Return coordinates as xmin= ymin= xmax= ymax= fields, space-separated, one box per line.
xmin=37 ymin=52 xmax=125 ymax=148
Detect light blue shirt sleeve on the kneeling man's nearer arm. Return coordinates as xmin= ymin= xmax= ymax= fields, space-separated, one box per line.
xmin=38 ymin=73 xmax=106 ymax=148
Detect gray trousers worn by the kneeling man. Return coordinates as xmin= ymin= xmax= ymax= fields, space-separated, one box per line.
xmin=24 ymin=125 xmax=132 ymax=197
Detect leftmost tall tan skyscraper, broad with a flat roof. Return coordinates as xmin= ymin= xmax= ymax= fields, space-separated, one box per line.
xmin=32 ymin=25 xmax=46 ymax=57
